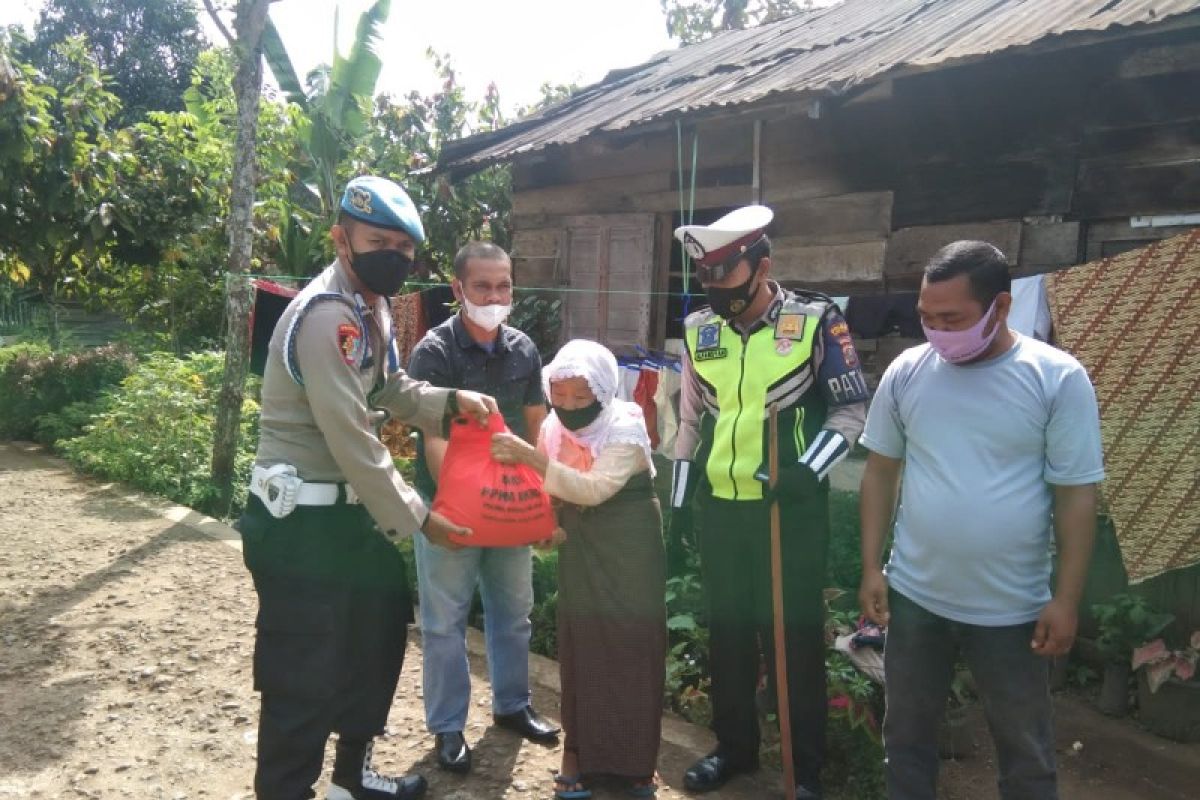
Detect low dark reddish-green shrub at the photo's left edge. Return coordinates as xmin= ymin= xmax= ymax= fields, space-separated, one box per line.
xmin=0 ymin=344 xmax=136 ymax=444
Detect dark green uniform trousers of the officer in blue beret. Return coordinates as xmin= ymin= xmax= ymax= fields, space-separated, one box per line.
xmin=239 ymin=497 xmax=412 ymax=800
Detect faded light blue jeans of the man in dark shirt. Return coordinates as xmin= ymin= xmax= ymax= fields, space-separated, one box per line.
xmin=413 ymin=534 xmax=533 ymax=733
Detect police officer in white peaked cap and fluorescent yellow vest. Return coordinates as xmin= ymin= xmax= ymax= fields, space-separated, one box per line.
xmin=668 ymin=205 xmax=866 ymax=800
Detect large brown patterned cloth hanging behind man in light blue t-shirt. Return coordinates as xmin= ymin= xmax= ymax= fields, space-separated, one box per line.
xmin=1045 ymin=228 xmax=1200 ymax=584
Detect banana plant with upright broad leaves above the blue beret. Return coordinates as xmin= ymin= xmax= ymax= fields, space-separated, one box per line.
xmin=263 ymin=0 xmax=391 ymax=221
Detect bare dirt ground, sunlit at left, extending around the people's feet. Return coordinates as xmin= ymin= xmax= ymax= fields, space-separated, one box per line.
xmin=0 ymin=445 xmax=1200 ymax=800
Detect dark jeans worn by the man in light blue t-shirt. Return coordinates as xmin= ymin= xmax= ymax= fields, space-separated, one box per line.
xmin=883 ymin=590 xmax=1058 ymax=800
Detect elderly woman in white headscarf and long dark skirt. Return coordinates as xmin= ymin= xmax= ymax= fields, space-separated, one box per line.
xmin=492 ymin=339 xmax=667 ymax=800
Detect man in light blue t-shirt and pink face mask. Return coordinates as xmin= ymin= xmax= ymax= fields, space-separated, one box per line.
xmin=859 ymin=241 xmax=1104 ymax=800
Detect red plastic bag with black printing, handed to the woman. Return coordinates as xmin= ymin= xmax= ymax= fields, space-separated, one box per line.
xmin=433 ymin=414 xmax=557 ymax=547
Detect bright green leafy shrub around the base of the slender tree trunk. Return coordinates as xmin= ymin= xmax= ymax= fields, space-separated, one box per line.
xmin=62 ymin=353 xmax=258 ymax=513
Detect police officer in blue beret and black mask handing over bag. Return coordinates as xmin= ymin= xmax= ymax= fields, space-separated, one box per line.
xmin=239 ymin=176 xmax=497 ymax=800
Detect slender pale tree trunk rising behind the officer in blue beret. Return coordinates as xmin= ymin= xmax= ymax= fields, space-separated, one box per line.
xmin=212 ymin=0 xmax=271 ymax=516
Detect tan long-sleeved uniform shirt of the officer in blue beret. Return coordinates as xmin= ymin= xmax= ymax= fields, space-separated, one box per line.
xmin=256 ymin=261 xmax=450 ymax=536
